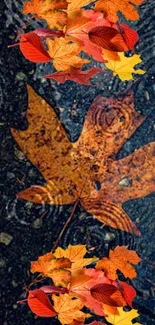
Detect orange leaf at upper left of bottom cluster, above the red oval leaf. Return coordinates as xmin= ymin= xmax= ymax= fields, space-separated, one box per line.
xmin=31 ymin=253 xmax=71 ymax=287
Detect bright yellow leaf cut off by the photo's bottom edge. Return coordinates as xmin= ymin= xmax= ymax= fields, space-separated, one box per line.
xmin=106 ymin=307 xmax=141 ymax=325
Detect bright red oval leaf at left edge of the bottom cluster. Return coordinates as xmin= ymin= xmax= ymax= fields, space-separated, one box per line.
xmin=27 ymin=289 xmax=57 ymax=317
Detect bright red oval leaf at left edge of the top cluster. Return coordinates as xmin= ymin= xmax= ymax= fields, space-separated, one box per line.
xmin=19 ymin=32 xmax=51 ymax=63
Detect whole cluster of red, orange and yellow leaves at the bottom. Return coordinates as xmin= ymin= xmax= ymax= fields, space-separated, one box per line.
xmin=20 ymin=245 xmax=141 ymax=325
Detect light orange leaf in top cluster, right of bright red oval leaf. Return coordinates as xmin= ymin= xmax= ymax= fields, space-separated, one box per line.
xmin=46 ymin=37 xmax=89 ymax=71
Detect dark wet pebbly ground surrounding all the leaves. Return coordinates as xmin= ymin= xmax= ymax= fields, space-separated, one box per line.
xmin=0 ymin=0 xmax=155 ymax=325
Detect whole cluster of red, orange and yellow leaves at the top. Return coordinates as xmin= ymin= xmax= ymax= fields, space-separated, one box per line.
xmin=10 ymin=0 xmax=144 ymax=85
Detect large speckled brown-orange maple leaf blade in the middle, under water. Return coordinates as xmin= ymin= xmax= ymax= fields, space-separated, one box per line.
xmin=12 ymin=87 xmax=155 ymax=235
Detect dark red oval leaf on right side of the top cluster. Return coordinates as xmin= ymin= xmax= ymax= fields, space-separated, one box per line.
xmin=88 ymin=26 xmax=128 ymax=52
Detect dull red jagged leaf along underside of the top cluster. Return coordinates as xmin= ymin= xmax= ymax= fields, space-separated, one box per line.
xmin=43 ymin=67 xmax=104 ymax=85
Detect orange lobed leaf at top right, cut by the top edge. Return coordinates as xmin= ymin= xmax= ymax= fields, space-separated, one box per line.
xmin=94 ymin=0 xmax=144 ymax=23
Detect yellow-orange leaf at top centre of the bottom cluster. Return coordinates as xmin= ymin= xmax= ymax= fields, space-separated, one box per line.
xmin=54 ymin=245 xmax=97 ymax=271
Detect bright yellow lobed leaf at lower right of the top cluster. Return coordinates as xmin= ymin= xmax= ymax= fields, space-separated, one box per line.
xmin=105 ymin=53 xmax=145 ymax=81
